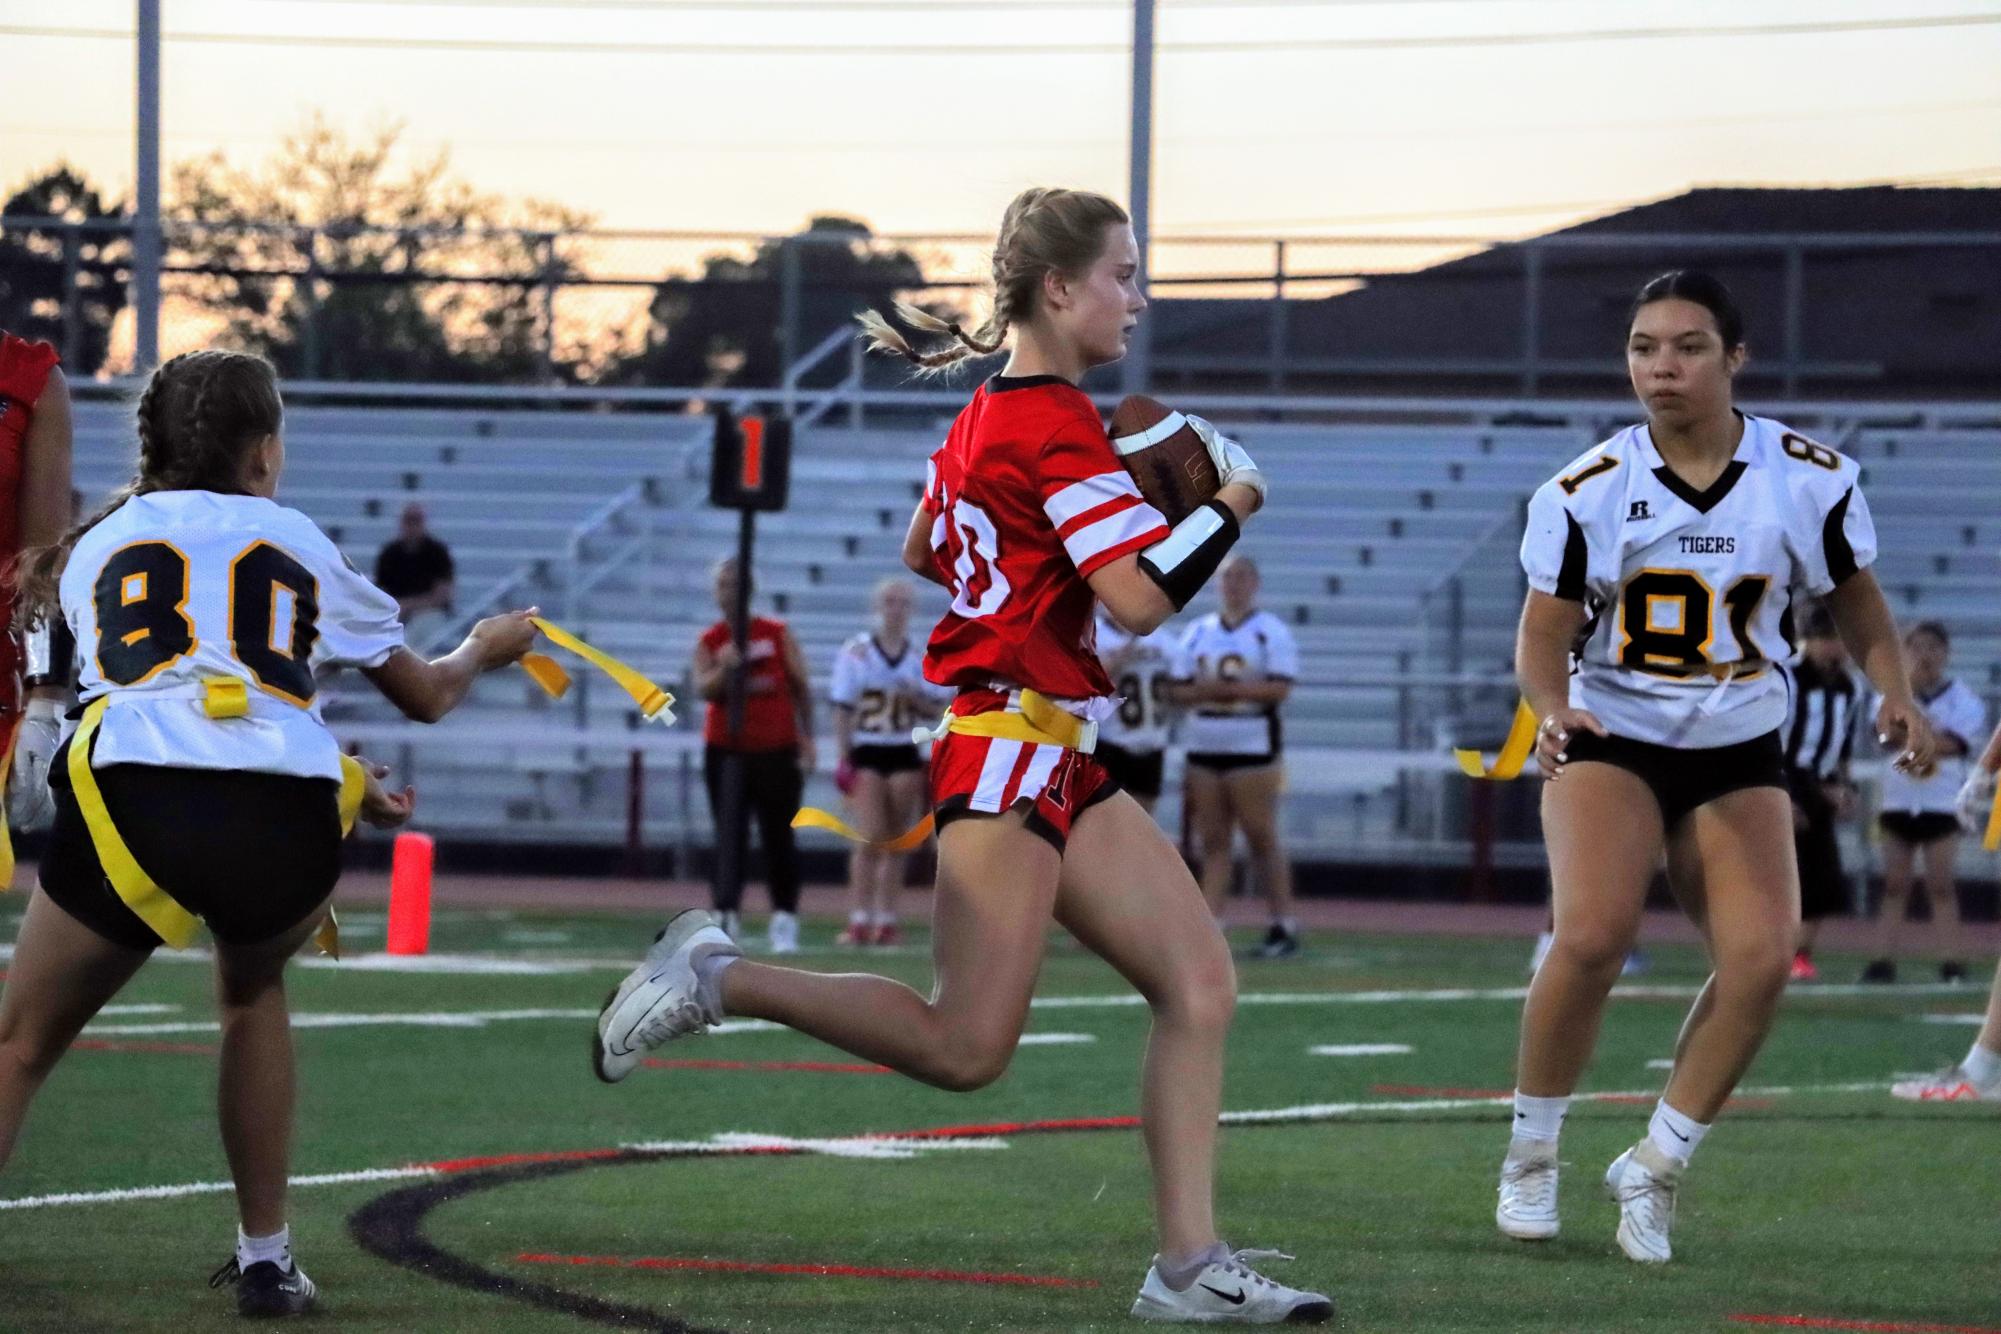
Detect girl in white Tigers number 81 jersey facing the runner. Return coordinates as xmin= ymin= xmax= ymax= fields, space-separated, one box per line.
xmin=1495 ymin=272 xmax=1935 ymax=1262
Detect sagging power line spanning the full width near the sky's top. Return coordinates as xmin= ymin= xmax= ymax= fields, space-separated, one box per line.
xmin=15 ymin=14 xmax=2001 ymax=60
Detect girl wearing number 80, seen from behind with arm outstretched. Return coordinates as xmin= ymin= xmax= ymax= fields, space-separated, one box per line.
xmin=0 ymin=352 xmax=534 ymax=1316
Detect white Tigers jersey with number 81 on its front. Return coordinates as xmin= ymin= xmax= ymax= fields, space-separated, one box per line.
xmin=1521 ymin=414 xmax=1875 ymax=748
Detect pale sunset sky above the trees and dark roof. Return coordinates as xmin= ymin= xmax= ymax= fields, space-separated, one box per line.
xmin=0 ymin=0 xmax=2001 ymax=245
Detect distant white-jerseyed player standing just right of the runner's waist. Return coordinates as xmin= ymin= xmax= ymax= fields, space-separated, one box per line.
xmin=1169 ymin=554 xmax=1299 ymax=958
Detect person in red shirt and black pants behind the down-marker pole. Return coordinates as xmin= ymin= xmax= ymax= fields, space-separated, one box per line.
xmin=694 ymin=556 xmax=814 ymax=954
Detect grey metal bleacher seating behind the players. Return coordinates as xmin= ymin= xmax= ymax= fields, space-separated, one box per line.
xmin=54 ymin=404 xmax=2001 ymax=856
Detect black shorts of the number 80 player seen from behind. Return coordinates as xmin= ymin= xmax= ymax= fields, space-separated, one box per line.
xmin=42 ymin=746 xmax=340 ymax=950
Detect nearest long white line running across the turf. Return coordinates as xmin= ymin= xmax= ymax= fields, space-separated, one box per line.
xmin=0 ymin=1080 xmax=1887 ymax=1210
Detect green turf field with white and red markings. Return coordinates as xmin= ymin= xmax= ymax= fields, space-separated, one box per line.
xmin=0 ymin=902 xmax=2001 ymax=1334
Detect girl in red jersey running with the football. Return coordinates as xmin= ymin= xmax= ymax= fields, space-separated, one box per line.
xmin=594 ymin=190 xmax=1333 ymax=1324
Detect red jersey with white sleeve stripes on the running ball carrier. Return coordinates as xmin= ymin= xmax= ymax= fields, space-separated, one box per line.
xmin=924 ymin=376 xmax=1169 ymax=700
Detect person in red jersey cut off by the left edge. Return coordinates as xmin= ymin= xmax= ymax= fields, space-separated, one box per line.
xmin=0 ymin=332 xmax=72 ymax=836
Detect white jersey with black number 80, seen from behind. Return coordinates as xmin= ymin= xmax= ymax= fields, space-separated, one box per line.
xmin=62 ymin=490 xmax=402 ymax=780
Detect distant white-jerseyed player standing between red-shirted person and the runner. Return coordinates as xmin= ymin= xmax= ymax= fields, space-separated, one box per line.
xmin=826 ymin=578 xmax=946 ymax=946
